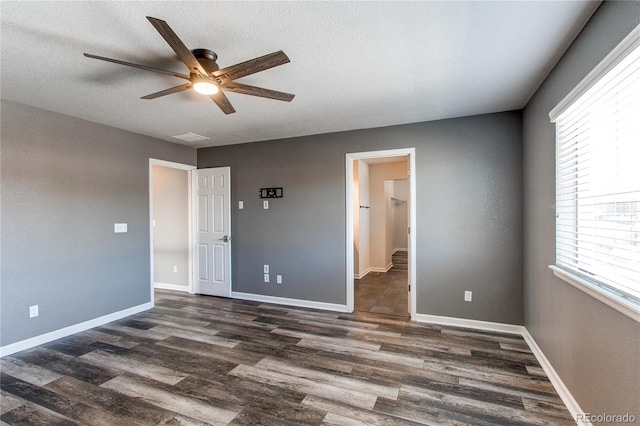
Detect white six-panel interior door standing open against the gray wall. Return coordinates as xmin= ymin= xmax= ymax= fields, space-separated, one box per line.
xmin=192 ymin=167 xmax=231 ymax=297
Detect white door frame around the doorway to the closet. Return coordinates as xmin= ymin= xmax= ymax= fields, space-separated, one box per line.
xmin=345 ymin=148 xmax=417 ymax=320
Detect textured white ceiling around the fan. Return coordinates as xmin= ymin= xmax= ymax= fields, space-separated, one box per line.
xmin=0 ymin=1 xmax=598 ymax=147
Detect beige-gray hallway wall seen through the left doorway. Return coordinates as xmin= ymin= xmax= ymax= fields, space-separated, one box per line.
xmin=153 ymin=166 xmax=191 ymax=291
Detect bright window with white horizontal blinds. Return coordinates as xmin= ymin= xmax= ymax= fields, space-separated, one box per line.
xmin=550 ymin=21 xmax=640 ymax=317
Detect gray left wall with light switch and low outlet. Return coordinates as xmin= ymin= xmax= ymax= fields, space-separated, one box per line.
xmin=0 ymin=101 xmax=196 ymax=346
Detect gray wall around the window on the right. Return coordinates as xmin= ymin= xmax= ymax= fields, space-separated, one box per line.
xmin=523 ymin=2 xmax=640 ymax=419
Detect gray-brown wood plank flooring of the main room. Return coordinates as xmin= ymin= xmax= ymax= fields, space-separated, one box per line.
xmin=0 ymin=291 xmax=575 ymax=426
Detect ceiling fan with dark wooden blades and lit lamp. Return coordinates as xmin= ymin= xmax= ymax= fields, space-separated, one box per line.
xmin=84 ymin=16 xmax=295 ymax=114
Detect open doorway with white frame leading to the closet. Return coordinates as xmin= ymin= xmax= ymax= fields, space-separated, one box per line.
xmin=346 ymin=148 xmax=415 ymax=318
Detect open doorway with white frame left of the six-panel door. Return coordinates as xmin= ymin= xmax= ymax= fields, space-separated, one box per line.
xmin=149 ymin=159 xmax=195 ymax=300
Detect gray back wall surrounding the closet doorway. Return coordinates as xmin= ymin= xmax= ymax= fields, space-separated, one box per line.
xmin=198 ymin=112 xmax=523 ymax=324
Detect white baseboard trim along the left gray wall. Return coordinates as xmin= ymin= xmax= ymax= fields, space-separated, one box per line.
xmin=0 ymin=302 xmax=153 ymax=358
